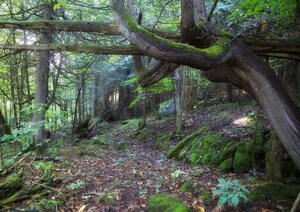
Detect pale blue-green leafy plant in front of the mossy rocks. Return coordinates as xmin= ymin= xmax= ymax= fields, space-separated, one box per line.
xmin=213 ymin=178 xmax=249 ymax=207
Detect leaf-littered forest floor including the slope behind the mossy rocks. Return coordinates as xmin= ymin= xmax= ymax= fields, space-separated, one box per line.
xmin=4 ymin=101 xmax=291 ymax=212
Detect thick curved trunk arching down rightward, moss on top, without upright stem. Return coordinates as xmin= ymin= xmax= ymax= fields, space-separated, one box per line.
xmin=111 ymin=0 xmax=300 ymax=170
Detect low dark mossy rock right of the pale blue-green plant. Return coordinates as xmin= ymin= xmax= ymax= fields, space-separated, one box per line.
xmin=249 ymin=183 xmax=300 ymax=202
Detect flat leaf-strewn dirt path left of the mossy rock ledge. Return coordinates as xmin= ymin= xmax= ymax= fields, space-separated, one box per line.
xmin=58 ymin=127 xmax=250 ymax=211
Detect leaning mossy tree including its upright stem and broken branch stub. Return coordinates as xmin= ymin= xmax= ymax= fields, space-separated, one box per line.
xmin=111 ymin=0 xmax=300 ymax=170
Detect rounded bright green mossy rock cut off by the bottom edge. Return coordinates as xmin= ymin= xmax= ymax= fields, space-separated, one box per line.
xmin=147 ymin=194 xmax=191 ymax=212
